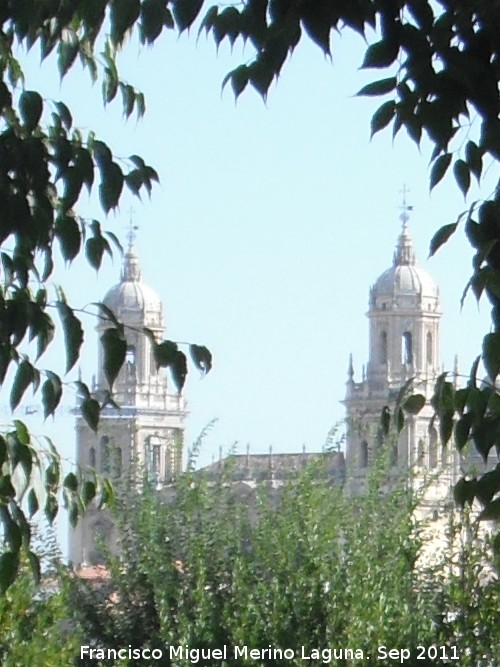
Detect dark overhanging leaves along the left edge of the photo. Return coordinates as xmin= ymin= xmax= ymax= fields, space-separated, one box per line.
xmin=0 ymin=0 xmax=215 ymax=594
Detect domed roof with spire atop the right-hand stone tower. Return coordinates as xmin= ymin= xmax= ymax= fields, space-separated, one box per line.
xmin=372 ymin=222 xmax=439 ymax=298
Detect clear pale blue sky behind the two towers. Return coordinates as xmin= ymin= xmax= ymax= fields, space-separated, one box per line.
xmin=11 ymin=24 xmax=491 ymax=548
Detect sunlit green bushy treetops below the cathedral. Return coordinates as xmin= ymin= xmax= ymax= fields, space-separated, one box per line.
xmin=70 ymin=455 xmax=500 ymax=667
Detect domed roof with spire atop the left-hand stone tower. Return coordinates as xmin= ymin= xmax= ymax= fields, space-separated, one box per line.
xmin=103 ymin=242 xmax=163 ymax=319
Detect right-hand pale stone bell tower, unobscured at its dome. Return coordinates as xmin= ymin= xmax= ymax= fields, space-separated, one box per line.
xmin=344 ymin=189 xmax=445 ymax=491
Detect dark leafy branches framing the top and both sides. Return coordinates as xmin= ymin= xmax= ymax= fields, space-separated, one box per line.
xmin=0 ymin=0 xmax=500 ymax=592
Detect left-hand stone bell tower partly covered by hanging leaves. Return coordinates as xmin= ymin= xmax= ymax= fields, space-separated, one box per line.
xmin=70 ymin=230 xmax=186 ymax=566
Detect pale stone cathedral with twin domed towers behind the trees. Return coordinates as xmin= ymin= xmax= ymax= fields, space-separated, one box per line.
xmin=70 ymin=204 xmax=459 ymax=565
